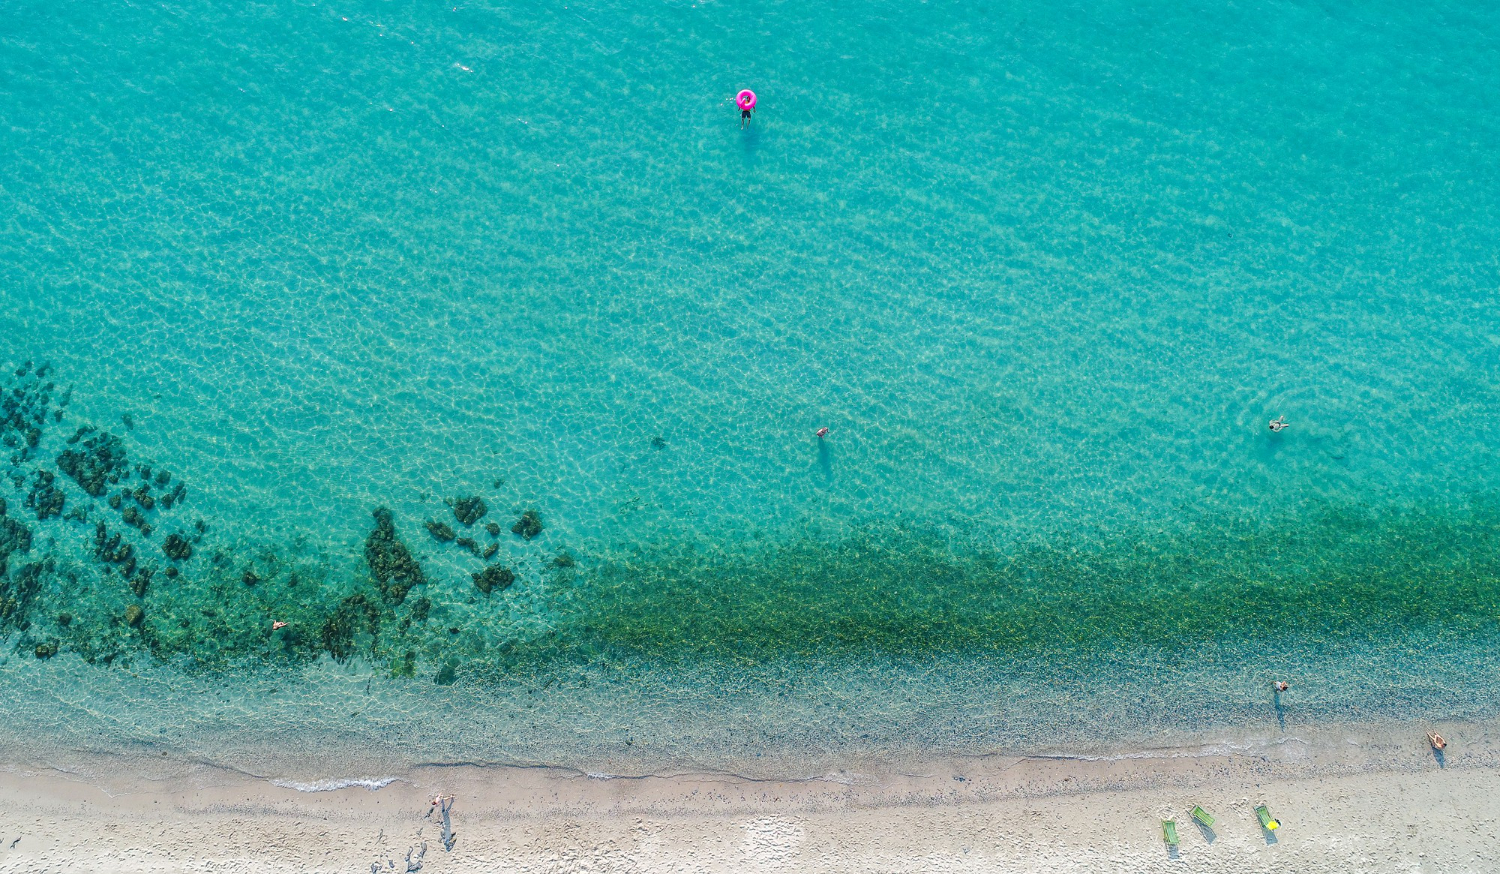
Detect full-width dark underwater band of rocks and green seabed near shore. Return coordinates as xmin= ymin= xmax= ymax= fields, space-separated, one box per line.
xmin=0 ymin=369 xmax=1500 ymax=682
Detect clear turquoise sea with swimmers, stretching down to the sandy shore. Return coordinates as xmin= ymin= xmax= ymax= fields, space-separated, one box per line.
xmin=0 ymin=3 xmax=1500 ymax=772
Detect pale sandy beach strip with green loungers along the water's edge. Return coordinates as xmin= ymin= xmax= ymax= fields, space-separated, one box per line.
xmin=0 ymin=726 xmax=1500 ymax=874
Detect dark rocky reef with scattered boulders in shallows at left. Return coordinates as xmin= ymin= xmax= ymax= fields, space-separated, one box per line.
xmin=0 ymin=364 xmax=567 ymax=679
